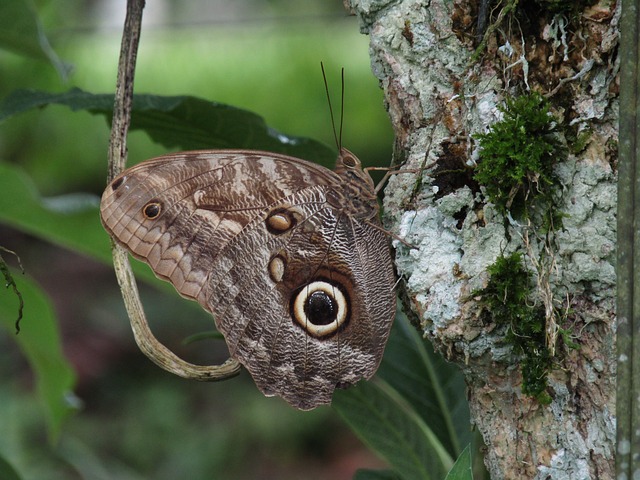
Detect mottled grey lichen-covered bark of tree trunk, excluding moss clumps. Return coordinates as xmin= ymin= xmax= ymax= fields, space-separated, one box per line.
xmin=345 ymin=0 xmax=620 ymax=480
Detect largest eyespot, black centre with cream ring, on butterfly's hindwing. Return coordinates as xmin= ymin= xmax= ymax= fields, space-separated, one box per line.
xmin=291 ymin=280 xmax=349 ymax=338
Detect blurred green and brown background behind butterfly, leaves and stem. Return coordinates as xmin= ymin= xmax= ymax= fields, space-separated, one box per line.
xmin=0 ymin=0 xmax=392 ymax=479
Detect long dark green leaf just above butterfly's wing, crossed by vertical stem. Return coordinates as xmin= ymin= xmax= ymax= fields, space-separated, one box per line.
xmin=0 ymin=88 xmax=336 ymax=167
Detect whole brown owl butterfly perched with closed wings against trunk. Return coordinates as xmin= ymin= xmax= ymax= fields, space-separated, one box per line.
xmin=100 ymin=76 xmax=396 ymax=410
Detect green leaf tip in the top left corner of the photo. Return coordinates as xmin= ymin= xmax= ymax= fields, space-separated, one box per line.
xmin=0 ymin=0 xmax=69 ymax=80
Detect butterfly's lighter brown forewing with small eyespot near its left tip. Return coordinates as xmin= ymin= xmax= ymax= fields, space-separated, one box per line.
xmin=100 ymin=151 xmax=331 ymax=309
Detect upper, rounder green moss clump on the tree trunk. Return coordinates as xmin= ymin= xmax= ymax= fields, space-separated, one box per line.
xmin=474 ymin=93 xmax=566 ymax=214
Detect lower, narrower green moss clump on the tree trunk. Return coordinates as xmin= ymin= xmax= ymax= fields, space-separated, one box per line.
xmin=474 ymin=252 xmax=551 ymax=404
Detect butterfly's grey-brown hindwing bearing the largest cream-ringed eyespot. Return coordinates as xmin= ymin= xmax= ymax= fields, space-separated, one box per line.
xmin=212 ymin=205 xmax=395 ymax=409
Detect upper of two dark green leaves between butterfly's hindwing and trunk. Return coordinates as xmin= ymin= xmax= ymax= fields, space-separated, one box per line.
xmin=378 ymin=312 xmax=471 ymax=458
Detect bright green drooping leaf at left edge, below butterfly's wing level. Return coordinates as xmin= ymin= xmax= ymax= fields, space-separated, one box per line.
xmin=0 ymin=272 xmax=75 ymax=440
